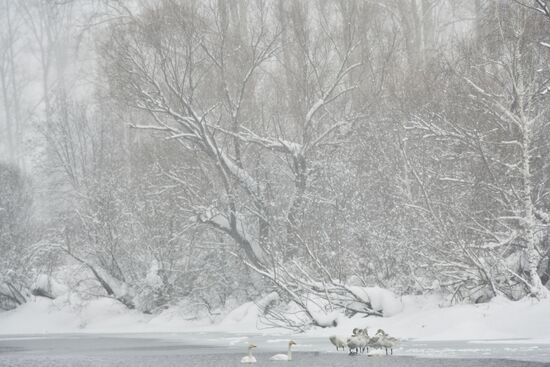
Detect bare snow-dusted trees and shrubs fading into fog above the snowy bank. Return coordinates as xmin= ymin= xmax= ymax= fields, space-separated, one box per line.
xmin=0 ymin=0 xmax=550 ymax=329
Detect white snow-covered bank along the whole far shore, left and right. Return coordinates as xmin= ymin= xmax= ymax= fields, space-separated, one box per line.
xmin=0 ymin=296 xmax=550 ymax=344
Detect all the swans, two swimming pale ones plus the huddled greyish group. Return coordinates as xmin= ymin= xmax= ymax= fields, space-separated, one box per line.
xmin=241 ymin=328 xmax=399 ymax=363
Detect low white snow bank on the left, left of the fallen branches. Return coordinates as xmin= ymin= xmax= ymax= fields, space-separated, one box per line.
xmin=0 ymin=294 xmax=275 ymax=335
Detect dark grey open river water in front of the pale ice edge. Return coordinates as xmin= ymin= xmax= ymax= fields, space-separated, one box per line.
xmin=0 ymin=335 xmax=550 ymax=367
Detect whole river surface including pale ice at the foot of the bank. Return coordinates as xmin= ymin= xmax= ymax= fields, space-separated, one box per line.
xmin=0 ymin=333 xmax=550 ymax=367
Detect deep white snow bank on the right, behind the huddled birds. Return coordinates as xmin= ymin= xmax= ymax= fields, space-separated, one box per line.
xmin=308 ymin=296 xmax=550 ymax=343
